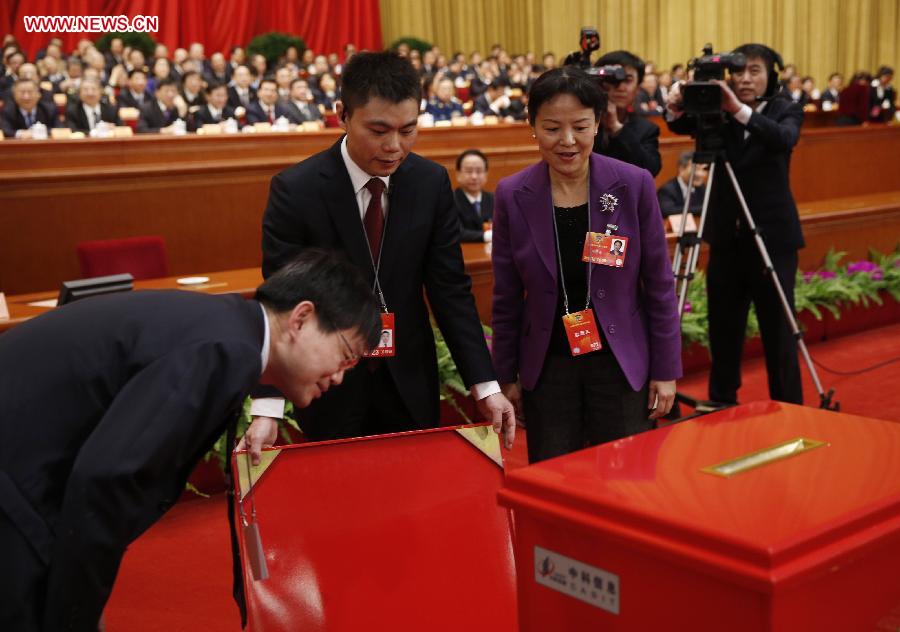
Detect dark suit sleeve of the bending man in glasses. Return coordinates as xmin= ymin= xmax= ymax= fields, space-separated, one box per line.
xmin=44 ymin=343 xmax=259 ymax=632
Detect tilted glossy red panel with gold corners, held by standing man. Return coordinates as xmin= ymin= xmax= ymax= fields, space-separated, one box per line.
xmin=233 ymin=425 xmax=516 ymax=632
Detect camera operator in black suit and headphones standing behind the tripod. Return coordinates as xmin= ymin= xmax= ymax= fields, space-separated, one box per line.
xmin=666 ymin=44 xmax=804 ymax=404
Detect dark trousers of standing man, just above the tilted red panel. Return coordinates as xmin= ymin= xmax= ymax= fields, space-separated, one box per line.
xmin=297 ymin=360 xmax=418 ymax=441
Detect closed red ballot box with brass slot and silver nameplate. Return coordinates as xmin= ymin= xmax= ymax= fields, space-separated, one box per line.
xmin=499 ymin=402 xmax=900 ymax=632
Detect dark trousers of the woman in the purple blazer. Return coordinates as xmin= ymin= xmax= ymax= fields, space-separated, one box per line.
xmin=522 ymin=353 xmax=653 ymax=463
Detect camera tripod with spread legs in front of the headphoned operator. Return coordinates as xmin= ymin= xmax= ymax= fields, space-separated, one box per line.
xmin=672 ymin=148 xmax=840 ymax=417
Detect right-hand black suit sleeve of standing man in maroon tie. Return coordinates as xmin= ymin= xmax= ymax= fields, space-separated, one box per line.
xmin=425 ymin=171 xmax=496 ymax=387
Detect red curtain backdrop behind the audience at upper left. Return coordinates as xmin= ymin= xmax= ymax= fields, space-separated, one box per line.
xmin=0 ymin=0 xmax=382 ymax=59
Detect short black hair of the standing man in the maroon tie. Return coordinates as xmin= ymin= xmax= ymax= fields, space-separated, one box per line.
xmin=341 ymin=51 xmax=422 ymax=116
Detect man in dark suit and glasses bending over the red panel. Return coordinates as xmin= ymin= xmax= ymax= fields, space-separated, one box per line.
xmin=0 ymin=251 xmax=381 ymax=632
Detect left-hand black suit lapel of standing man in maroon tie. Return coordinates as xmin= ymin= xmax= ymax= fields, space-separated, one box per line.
xmin=320 ymin=141 xmax=372 ymax=270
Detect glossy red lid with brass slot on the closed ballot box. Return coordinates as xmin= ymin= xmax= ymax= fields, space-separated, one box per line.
xmin=499 ymin=402 xmax=900 ymax=584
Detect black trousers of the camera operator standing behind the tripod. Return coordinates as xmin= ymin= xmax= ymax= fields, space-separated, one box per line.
xmin=706 ymin=238 xmax=803 ymax=404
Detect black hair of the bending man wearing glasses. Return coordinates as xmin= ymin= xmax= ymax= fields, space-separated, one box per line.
xmin=255 ymin=248 xmax=381 ymax=349
